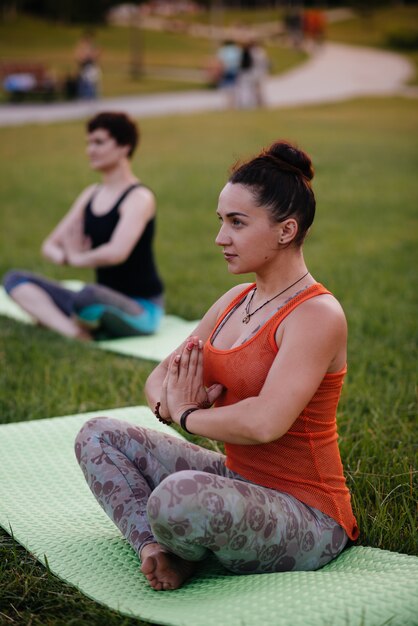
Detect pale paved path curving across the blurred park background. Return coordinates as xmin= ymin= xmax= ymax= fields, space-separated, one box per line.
xmin=0 ymin=42 xmax=417 ymax=126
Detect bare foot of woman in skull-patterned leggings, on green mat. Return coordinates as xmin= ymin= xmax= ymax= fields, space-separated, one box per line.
xmin=141 ymin=543 xmax=196 ymax=591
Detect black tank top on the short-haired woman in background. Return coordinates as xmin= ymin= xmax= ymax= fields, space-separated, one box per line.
xmin=84 ymin=183 xmax=163 ymax=298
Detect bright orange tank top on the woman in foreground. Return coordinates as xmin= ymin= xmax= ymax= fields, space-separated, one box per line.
xmin=204 ymin=283 xmax=359 ymax=539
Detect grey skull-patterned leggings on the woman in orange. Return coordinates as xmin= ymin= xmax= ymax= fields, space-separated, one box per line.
xmin=75 ymin=418 xmax=347 ymax=574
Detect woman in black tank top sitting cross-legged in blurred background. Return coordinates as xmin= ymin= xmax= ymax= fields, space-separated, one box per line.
xmin=4 ymin=112 xmax=164 ymax=339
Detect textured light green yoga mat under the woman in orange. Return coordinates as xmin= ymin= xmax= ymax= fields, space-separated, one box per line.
xmin=0 ymin=407 xmax=418 ymax=626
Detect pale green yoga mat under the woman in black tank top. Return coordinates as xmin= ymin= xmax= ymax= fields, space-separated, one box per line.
xmin=0 ymin=280 xmax=198 ymax=361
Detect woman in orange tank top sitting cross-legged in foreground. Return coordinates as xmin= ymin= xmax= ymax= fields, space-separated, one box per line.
xmin=76 ymin=141 xmax=358 ymax=590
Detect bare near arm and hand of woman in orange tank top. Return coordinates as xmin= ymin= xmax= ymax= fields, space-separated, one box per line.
xmin=167 ymin=296 xmax=346 ymax=444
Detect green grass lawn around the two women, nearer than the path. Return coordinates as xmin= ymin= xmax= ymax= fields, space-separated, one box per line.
xmin=0 ymin=99 xmax=418 ymax=626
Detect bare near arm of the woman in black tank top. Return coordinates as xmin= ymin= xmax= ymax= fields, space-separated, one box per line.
xmin=67 ymin=187 xmax=155 ymax=267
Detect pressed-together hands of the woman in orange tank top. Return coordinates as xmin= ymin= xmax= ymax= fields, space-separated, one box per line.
xmin=163 ymin=337 xmax=223 ymax=423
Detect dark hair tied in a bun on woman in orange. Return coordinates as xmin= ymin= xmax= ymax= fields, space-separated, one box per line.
xmin=229 ymin=141 xmax=316 ymax=246
